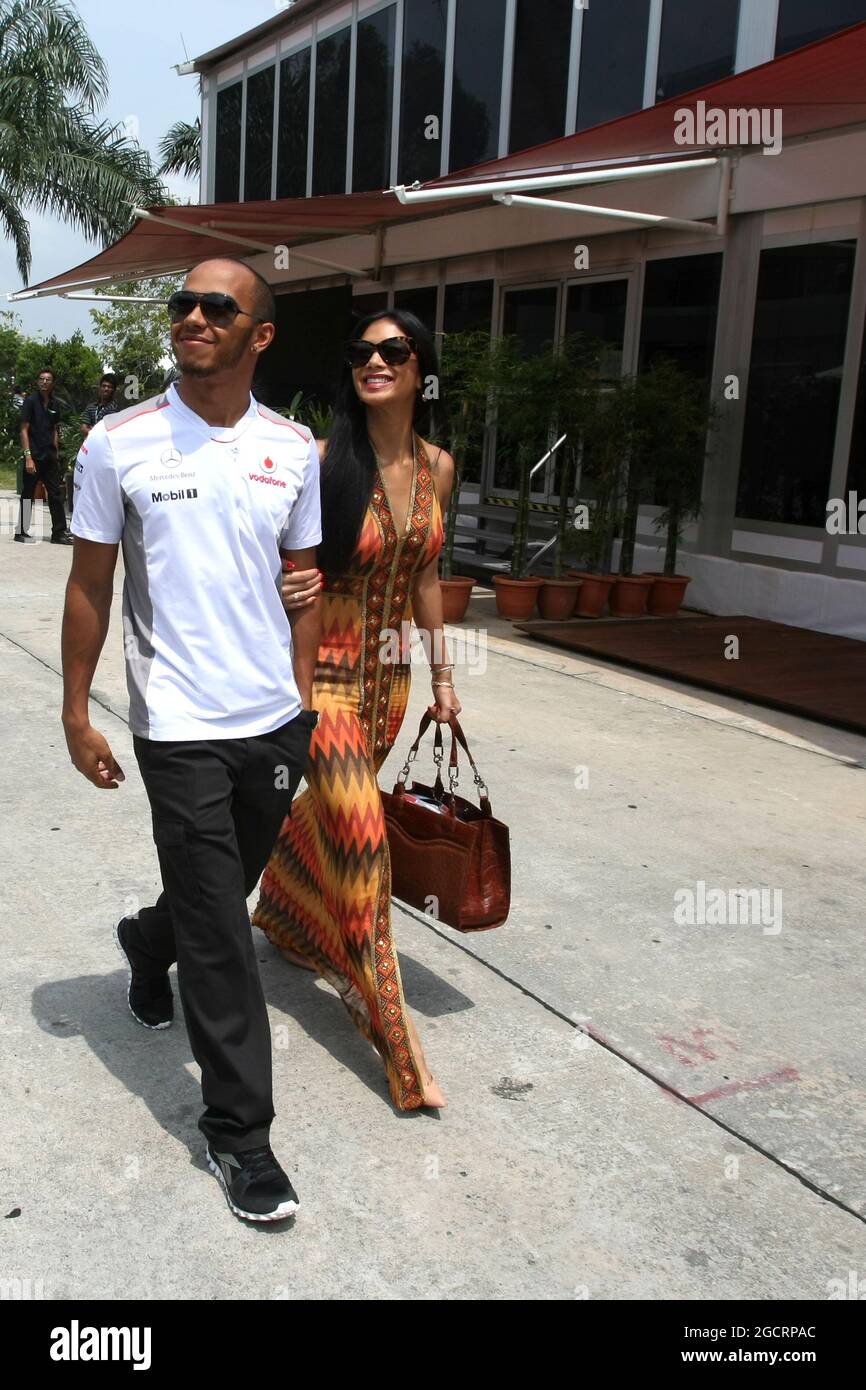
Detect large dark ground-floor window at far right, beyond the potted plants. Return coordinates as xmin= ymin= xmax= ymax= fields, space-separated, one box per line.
xmin=737 ymin=240 xmax=855 ymax=527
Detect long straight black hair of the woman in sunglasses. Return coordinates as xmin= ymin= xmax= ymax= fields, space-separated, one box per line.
xmin=317 ymin=309 xmax=446 ymax=574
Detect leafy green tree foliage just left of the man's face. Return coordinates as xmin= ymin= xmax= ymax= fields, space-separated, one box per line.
xmin=90 ymin=275 xmax=181 ymax=406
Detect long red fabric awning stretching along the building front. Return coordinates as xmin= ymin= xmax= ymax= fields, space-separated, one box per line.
xmin=11 ymin=21 xmax=866 ymax=303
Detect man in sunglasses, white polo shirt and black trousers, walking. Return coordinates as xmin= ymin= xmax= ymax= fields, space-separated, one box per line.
xmin=63 ymin=259 xmax=321 ymax=1220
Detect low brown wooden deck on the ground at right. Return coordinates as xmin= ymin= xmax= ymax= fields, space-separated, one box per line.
xmin=514 ymin=613 xmax=866 ymax=734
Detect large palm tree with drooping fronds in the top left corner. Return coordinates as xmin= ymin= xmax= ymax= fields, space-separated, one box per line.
xmin=0 ymin=0 xmax=167 ymax=282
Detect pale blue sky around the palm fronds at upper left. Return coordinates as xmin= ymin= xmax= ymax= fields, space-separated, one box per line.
xmin=0 ymin=0 xmax=282 ymax=339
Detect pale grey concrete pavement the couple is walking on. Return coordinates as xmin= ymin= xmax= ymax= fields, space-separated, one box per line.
xmin=0 ymin=511 xmax=866 ymax=1300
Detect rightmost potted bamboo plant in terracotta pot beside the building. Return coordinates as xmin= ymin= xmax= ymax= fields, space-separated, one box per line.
xmin=641 ymin=359 xmax=717 ymax=617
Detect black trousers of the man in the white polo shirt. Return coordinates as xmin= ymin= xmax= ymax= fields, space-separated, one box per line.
xmin=129 ymin=710 xmax=318 ymax=1151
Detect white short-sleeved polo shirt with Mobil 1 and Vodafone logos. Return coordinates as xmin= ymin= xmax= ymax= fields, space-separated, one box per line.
xmin=72 ymin=385 xmax=321 ymax=739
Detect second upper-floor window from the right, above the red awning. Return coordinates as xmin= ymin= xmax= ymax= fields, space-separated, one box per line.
xmin=656 ymin=0 xmax=739 ymax=101
